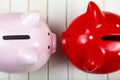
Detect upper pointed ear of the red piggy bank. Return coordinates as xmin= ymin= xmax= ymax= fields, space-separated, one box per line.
xmin=87 ymin=1 xmax=105 ymax=25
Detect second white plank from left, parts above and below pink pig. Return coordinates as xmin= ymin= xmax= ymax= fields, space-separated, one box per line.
xmin=10 ymin=0 xmax=28 ymax=80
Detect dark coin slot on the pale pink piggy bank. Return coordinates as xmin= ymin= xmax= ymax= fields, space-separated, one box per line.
xmin=3 ymin=35 xmax=30 ymax=40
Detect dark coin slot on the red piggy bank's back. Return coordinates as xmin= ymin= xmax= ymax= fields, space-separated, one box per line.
xmin=101 ymin=35 xmax=120 ymax=41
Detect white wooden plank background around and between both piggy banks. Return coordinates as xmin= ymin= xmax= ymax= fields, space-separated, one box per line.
xmin=0 ymin=0 xmax=120 ymax=80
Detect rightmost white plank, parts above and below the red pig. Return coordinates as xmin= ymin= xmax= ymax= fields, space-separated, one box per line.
xmin=104 ymin=0 xmax=120 ymax=80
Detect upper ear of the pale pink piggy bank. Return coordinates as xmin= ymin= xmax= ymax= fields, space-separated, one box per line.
xmin=21 ymin=12 xmax=40 ymax=27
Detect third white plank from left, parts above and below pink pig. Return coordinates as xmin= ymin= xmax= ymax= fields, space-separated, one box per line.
xmin=29 ymin=0 xmax=48 ymax=80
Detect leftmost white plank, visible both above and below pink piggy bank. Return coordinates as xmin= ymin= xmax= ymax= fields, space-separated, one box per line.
xmin=0 ymin=0 xmax=10 ymax=80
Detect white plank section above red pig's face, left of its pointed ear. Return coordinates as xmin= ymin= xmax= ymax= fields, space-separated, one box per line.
xmin=67 ymin=0 xmax=87 ymax=25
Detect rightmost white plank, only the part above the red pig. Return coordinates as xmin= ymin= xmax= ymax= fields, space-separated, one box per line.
xmin=104 ymin=0 xmax=120 ymax=15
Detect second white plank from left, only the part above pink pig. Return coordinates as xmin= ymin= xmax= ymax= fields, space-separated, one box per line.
xmin=11 ymin=0 xmax=28 ymax=12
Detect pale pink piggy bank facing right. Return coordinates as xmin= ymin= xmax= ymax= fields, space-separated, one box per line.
xmin=0 ymin=12 xmax=56 ymax=73
